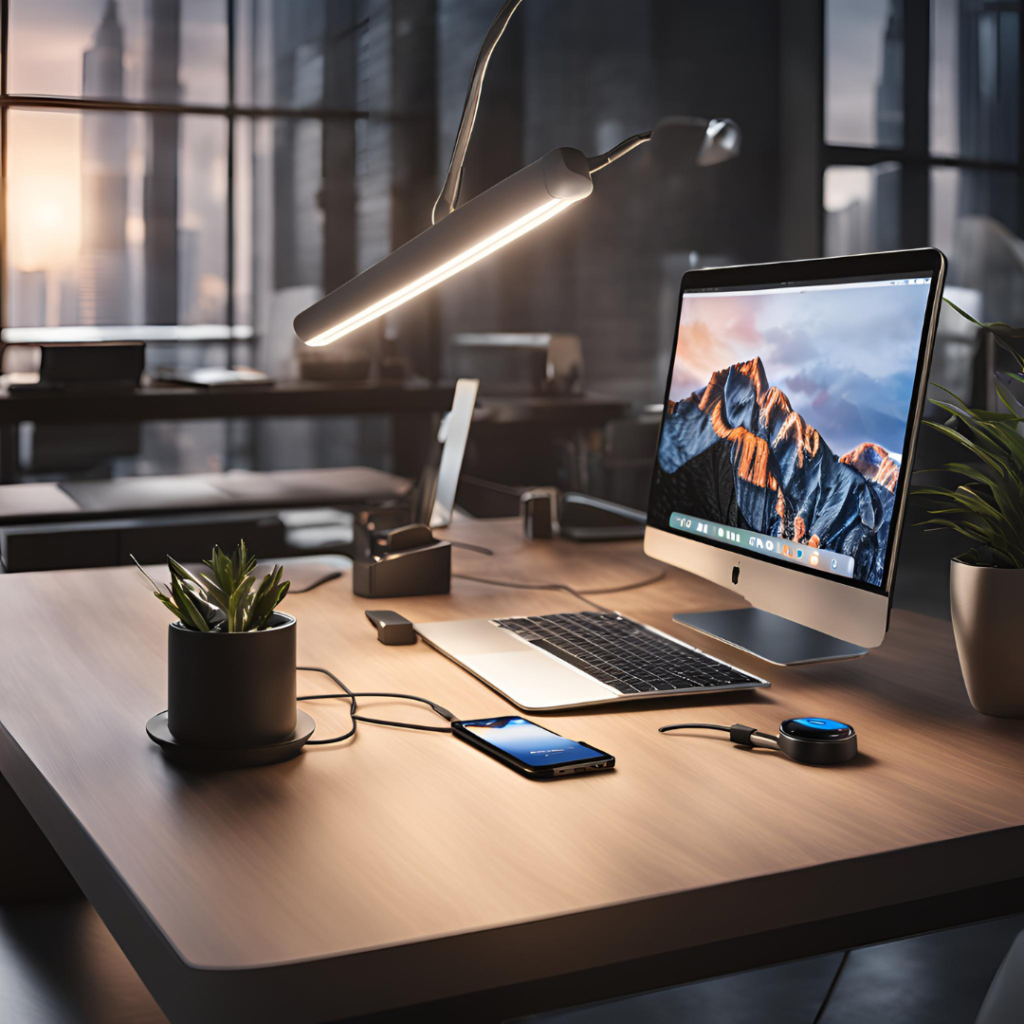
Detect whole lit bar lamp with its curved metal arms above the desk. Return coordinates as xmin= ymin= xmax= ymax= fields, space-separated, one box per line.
xmin=295 ymin=0 xmax=740 ymax=346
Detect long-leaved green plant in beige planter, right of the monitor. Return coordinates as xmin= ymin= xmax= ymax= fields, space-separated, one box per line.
xmin=918 ymin=299 xmax=1024 ymax=718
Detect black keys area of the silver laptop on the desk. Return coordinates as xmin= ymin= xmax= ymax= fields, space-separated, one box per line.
xmin=496 ymin=611 xmax=769 ymax=694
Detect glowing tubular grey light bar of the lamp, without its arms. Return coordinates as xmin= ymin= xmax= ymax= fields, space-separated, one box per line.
xmin=295 ymin=150 xmax=594 ymax=347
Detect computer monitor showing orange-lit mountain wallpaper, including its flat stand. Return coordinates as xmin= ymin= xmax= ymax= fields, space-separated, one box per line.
xmin=644 ymin=249 xmax=946 ymax=665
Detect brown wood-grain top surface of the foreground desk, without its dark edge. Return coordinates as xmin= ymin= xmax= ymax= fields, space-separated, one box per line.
xmin=0 ymin=521 xmax=1024 ymax=1015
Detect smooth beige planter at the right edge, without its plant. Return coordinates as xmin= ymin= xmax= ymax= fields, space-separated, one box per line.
xmin=949 ymin=558 xmax=1024 ymax=718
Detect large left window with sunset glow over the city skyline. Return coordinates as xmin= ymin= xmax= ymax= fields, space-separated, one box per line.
xmin=0 ymin=0 xmax=419 ymax=372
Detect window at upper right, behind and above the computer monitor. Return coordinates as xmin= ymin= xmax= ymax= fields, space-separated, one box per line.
xmin=822 ymin=0 xmax=1024 ymax=272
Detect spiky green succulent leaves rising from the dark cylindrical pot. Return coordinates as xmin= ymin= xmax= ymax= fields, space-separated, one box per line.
xmin=132 ymin=541 xmax=291 ymax=633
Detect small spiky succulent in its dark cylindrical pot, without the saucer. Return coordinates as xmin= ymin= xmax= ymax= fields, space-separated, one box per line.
xmin=135 ymin=541 xmax=296 ymax=750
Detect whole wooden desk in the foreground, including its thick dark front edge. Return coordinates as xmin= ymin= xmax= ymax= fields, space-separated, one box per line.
xmin=0 ymin=521 xmax=1024 ymax=1024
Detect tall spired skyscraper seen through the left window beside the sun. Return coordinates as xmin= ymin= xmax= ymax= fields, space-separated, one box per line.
xmin=78 ymin=0 xmax=129 ymax=325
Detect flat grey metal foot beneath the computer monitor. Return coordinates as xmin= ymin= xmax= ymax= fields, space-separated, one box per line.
xmin=673 ymin=608 xmax=867 ymax=665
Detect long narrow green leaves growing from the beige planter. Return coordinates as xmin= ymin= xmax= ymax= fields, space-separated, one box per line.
xmin=915 ymin=299 xmax=1024 ymax=569
